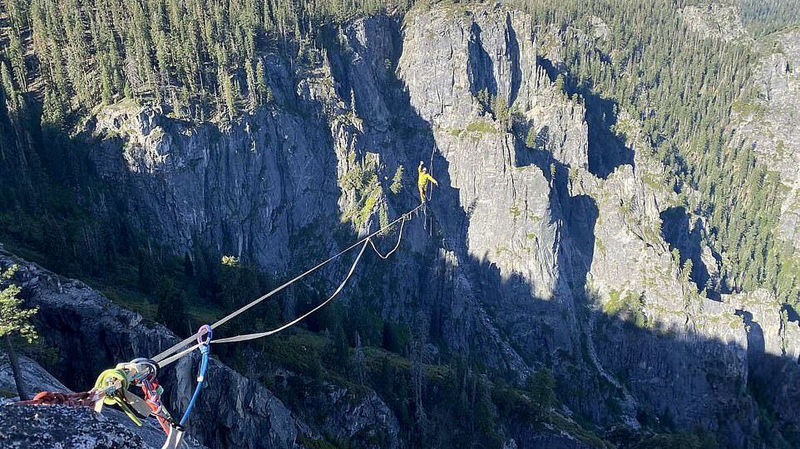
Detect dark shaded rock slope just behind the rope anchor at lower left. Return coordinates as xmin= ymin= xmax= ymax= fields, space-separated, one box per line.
xmin=0 ymin=248 xmax=296 ymax=447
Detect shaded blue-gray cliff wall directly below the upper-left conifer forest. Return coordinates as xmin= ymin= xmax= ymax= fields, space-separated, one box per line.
xmin=91 ymin=102 xmax=338 ymax=270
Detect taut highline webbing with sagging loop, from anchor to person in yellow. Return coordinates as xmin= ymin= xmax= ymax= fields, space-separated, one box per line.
xmin=151 ymin=204 xmax=422 ymax=368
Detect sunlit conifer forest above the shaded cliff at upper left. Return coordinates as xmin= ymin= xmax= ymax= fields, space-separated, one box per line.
xmin=3 ymin=0 xmax=411 ymax=124
